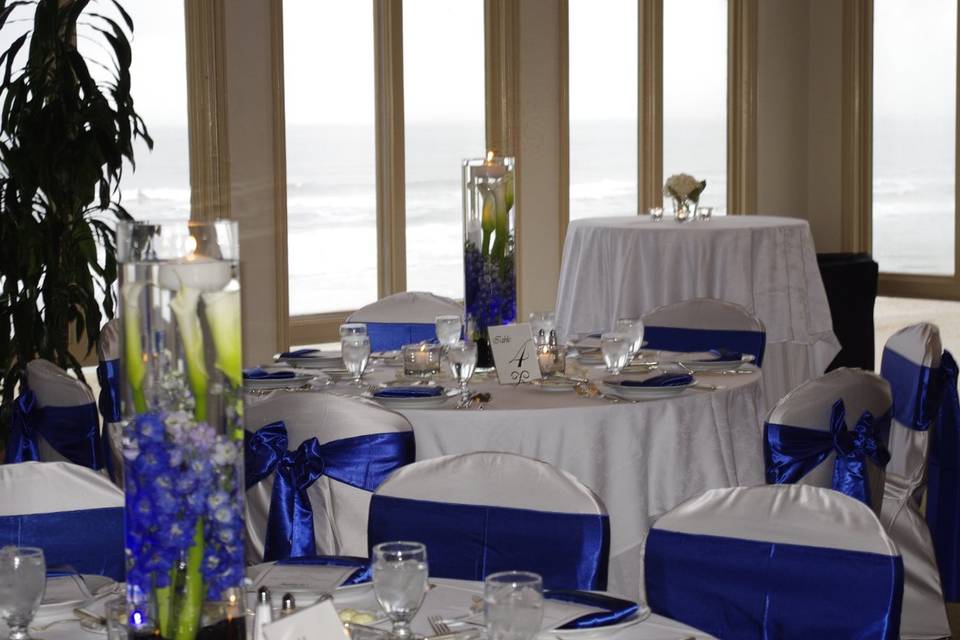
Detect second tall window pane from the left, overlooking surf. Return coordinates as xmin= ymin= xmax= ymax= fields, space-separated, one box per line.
xmin=283 ymin=0 xmax=377 ymax=316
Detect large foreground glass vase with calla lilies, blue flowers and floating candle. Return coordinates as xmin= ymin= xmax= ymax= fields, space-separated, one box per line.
xmin=117 ymin=221 xmax=245 ymax=640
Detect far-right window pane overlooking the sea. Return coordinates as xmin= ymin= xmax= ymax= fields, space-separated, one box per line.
xmin=873 ymin=0 xmax=957 ymax=275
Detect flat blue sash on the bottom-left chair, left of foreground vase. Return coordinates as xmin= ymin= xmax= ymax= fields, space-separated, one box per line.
xmin=0 ymin=508 xmax=124 ymax=581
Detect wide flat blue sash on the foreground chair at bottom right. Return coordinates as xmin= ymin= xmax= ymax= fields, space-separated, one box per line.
xmin=644 ymin=529 xmax=903 ymax=640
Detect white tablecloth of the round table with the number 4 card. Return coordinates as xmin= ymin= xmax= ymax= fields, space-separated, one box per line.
xmin=366 ymin=368 xmax=764 ymax=598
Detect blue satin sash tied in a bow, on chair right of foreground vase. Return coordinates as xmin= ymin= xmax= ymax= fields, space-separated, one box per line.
xmin=244 ymin=422 xmax=415 ymax=561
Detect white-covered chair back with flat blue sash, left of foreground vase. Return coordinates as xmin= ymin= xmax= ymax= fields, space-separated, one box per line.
xmin=0 ymin=462 xmax=124 ymax=580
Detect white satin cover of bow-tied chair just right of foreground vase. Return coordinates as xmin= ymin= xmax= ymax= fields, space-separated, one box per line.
xmin=245 ymin=391 xmax=413 ymax=563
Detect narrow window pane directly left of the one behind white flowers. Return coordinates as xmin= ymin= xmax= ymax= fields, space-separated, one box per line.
xmin=568 ymin=0 xmax=636 ymax=220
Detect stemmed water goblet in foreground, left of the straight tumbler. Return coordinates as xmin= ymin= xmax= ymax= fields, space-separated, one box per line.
xmin=373 ymin=542 xmax=428 ymax=640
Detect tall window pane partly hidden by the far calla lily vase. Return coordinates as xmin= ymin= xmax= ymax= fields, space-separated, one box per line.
xmin=403 ymin=0 xmax=486 ymax=298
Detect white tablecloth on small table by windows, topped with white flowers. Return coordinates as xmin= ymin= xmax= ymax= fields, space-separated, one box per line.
xmin=556 ymin=215 xmax=840 ymax=407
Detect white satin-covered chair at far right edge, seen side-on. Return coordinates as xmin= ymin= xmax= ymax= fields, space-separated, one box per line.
xmin=880 ymin=323 xmax=950 ymax=639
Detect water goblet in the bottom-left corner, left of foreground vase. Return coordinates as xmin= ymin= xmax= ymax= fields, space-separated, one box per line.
xmin=0 ymin=547 xmax=47 ymax=640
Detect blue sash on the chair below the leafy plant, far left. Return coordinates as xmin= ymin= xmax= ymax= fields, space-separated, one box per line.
xmin=4 ymin=389 xmax=103 ymax=470
